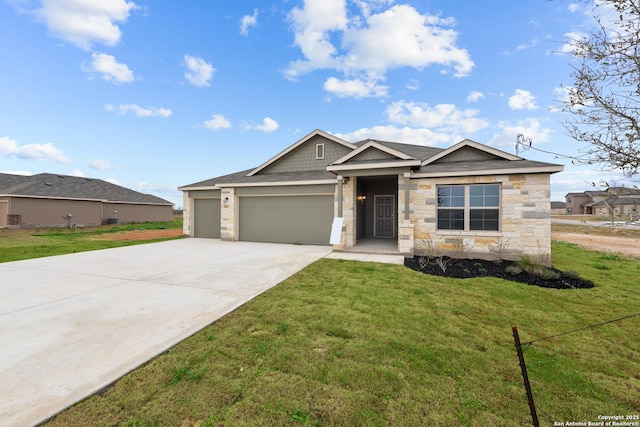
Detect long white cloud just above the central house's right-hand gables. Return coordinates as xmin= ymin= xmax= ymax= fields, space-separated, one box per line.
xmin=386 ymin=101 xmax=489 ymax=135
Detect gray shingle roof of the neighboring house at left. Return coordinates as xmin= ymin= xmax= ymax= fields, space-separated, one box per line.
xmin=0 ymin=173 xmax=173 ymax=205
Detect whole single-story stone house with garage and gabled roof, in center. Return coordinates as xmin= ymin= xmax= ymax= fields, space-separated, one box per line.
xmin=179 ymin=130 xmax=563 ymax=259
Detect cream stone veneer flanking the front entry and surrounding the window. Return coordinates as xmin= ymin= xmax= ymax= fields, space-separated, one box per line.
xmin=333 ymin=174 xmax=551 ymax=265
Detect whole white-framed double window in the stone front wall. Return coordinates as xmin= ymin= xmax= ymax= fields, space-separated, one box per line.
xmin=437 ymin=184 xmax=500 ymax=231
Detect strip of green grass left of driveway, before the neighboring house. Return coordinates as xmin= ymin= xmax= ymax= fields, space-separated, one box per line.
xmin=0 ymin=218 xmax=182 ymax=262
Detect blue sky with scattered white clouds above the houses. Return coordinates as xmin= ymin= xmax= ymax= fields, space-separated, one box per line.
xmin=0 ymin=0 xmax=637 ymax=207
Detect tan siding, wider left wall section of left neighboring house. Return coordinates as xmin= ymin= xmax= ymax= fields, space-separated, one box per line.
xmin=11 ymin=197 xmax=102 ymax=228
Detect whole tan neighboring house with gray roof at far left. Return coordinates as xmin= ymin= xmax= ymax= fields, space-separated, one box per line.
xmin=0 ymin=173 xmax=173 ymax=228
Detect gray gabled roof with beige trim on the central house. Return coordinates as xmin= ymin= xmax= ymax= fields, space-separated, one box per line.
xmin=178 ymin=130 xmax=564 ymax=191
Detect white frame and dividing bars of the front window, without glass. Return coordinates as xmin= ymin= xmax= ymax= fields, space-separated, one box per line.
xmin=435 ymin=183 xmax=502 ymax=233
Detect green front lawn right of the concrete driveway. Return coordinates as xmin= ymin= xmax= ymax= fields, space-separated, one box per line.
xmin=48 ymin=242 xmax=640 ymax=426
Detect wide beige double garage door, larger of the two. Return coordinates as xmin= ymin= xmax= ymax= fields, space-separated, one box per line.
xmin=238 ymin=195 xmax=333 ymax=245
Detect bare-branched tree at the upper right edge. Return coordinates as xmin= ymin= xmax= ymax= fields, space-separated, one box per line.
xmin=563 ymin=0 xmax=640 ymax=176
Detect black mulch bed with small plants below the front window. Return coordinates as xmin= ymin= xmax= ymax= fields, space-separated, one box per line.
xmin=404 ymin=256 xmax=594 ymax=289
